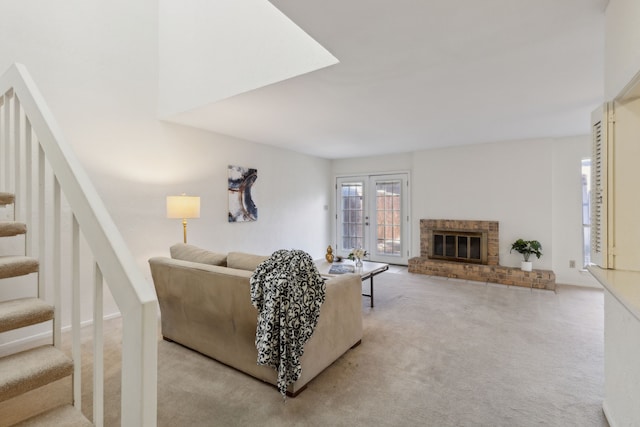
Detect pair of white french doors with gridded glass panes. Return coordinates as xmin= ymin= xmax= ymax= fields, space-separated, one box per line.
xmin=336 ymin=173 xmax=410 ymax=265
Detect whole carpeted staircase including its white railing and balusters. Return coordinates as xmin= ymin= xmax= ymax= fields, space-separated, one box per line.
xmin=0 ymin=64 xmax=158 ymax=427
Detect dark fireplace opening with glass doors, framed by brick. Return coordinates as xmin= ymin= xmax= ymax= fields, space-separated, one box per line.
xmin=429 ymin=230 xmax=487 ymax=264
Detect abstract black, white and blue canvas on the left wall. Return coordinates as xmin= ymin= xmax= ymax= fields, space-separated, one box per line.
xmin=229 ymin=165 xmax=258 ymax=222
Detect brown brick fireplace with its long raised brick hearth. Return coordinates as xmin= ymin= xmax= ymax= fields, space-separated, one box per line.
xmin=409 ymin=219 xmax=556 ymax=290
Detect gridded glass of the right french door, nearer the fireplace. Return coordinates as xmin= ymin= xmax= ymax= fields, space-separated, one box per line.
xmin=376 ymin=181 xmax=402 ymax=256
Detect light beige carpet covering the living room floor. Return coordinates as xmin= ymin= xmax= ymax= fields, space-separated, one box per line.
xmin=92 ymin=269 xmax=607 ymax=427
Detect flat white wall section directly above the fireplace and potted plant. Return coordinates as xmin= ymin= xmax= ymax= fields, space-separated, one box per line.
xmin=413 ymin=140 xmax=553 ymax=269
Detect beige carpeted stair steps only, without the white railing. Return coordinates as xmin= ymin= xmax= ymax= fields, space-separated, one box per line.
xmin=0 ymin=193 xmax=92 ymax=426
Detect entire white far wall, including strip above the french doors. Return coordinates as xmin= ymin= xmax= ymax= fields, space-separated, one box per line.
xmin=333 ymin=136 xmax=599 ymax=287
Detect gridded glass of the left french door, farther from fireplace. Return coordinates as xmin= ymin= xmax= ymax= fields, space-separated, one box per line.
xmin=340 ymin=182 xmax=364 ymax=251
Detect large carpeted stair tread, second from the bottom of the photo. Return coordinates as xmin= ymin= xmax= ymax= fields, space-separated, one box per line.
xmin=0 ymin=345 xmax=73 ymax=402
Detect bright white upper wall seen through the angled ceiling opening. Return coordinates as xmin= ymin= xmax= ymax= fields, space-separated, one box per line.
xmin=158 ymin=0 xmax=338 ymax=117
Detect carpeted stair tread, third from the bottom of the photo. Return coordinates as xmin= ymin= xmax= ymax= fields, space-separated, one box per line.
xmin=0 ymin=298 xmax=53 ymax=332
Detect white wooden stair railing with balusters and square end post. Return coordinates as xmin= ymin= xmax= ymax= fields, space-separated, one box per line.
xmin=0 ymin=64 xmax=158 ymax=426
